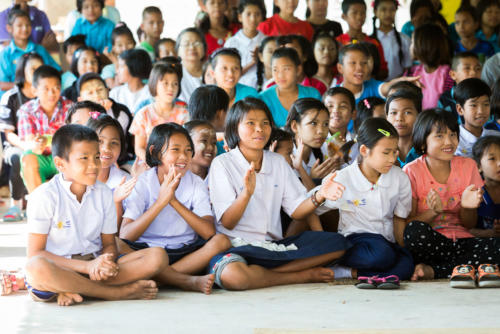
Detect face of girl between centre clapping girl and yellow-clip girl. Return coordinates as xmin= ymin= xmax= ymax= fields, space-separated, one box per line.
xmin=291 ymin=109 xmax=330 ymax=148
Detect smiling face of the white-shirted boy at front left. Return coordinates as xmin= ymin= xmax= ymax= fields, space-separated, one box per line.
xmin=54 ymin=141 xmax=101 ymax=186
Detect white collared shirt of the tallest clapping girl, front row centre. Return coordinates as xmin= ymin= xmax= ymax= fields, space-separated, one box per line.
xmin=208 ymin=148 xmax=307 ymax=241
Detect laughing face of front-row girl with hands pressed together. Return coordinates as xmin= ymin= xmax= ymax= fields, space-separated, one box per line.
xmin=158 ymin=133 xmax=193 ymax=176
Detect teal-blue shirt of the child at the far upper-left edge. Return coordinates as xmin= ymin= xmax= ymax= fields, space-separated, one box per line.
xmin=0 ymin=40 xmax=61 ymax=82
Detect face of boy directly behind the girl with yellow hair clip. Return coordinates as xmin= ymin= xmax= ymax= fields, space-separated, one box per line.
xmin=387 ymin=99 xmax=418 ymax=137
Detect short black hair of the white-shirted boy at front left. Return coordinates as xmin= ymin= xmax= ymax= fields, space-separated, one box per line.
xmin=52 ymin=124 xmax=99 ymax=161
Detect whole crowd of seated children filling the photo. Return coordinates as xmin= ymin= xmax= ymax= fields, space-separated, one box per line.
xmin=0 ymin=0 xmax=500 ymax=305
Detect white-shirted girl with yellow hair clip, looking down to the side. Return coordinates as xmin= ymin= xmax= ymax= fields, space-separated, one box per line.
xmin=316 ymin=118 xmax=414 ymax=288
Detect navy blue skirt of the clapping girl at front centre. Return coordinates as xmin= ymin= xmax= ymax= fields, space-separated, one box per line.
xmin=209 ymin=231 xmax=351 ymax=268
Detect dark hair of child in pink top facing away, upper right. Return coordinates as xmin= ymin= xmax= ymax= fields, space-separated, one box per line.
xmin=413 ymin=23 xmax=450 ymax=67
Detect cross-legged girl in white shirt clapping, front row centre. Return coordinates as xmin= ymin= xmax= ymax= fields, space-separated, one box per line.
xmin=208 ymin=97 xmax=347 ymax=290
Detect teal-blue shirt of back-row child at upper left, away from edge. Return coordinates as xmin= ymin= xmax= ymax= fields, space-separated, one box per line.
xmin=71 ymin=16 xmax=115 ymax=53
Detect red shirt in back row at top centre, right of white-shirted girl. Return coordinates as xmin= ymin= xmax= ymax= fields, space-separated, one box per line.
xmin=257 ymin=14 xmax=314 ymax=40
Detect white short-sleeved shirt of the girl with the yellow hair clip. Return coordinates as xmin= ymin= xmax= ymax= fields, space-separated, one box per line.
xmin=311 ymin=163 xmax=411 ymax=242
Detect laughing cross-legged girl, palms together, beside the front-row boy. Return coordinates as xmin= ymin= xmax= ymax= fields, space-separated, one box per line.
xmin=120 ymin=123 xmax=230 ymax=284
